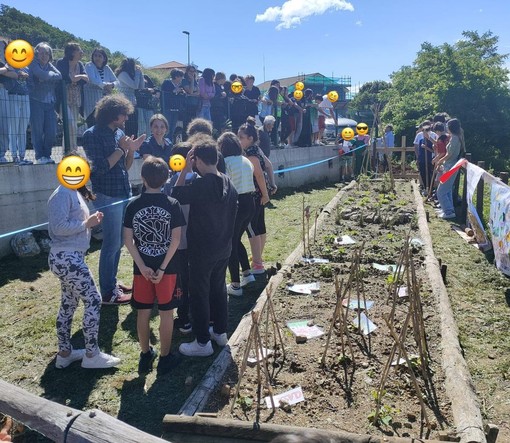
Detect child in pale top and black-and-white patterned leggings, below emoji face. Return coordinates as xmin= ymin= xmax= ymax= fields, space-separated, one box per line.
xmin=48 ymin=161 xmax=120 ymax=369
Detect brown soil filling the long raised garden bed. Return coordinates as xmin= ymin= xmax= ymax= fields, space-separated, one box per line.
xmin=205 ymin=180 xmax=453 ymax=438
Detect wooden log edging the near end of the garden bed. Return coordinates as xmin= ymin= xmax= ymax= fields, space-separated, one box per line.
xmin=163 ymin=414 xmax=442 ymax=443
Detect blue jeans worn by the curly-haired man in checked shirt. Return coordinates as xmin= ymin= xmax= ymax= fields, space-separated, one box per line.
xmin=94 ymin=193 xmax=128 ymax=298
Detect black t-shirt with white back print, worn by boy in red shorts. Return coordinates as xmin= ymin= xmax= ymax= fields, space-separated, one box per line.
xmin=124 ymin=193 xmax=186 ymax=275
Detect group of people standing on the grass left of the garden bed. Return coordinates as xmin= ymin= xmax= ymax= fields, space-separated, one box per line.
xmin=48 ymin=90 xmax=277 ymax=375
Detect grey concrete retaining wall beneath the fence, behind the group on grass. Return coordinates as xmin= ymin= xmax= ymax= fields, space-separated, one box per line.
xmin=0 ymin=146 xmax=340 ymax=257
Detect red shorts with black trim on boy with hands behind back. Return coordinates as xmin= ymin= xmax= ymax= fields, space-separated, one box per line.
xmin=131 ymin=274 xmax=181 ymax=311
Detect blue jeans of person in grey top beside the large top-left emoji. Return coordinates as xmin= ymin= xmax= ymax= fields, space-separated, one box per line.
xmin=30 ymin=100 xmax=57 ymax=160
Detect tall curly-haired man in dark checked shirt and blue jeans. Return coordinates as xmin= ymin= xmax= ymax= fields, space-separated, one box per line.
xmin=83 ymin=95 xmax=145 ymax=304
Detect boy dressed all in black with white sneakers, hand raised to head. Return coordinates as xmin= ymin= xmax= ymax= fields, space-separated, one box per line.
xmin=172 ymin=136 xmax=237 ymax=357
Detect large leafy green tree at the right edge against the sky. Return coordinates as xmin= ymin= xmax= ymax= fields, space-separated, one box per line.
xmin=382 ymin=31 xmax=510 ymax=170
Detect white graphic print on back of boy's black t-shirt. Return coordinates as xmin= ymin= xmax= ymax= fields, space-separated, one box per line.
xmin=133 ymin=206 xmax=172 ymax=257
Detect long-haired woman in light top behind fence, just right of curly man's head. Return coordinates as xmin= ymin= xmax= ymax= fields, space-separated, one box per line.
xmin=115 ymin=58 xmax=145 ymax=137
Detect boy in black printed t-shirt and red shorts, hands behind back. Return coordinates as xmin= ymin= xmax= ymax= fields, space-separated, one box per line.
xmin=124 ymin=156 xmax=185 ymax=376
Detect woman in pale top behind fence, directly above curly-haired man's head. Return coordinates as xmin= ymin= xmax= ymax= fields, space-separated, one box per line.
xmin=83 ymin=48 xmax=118 ymax=128
